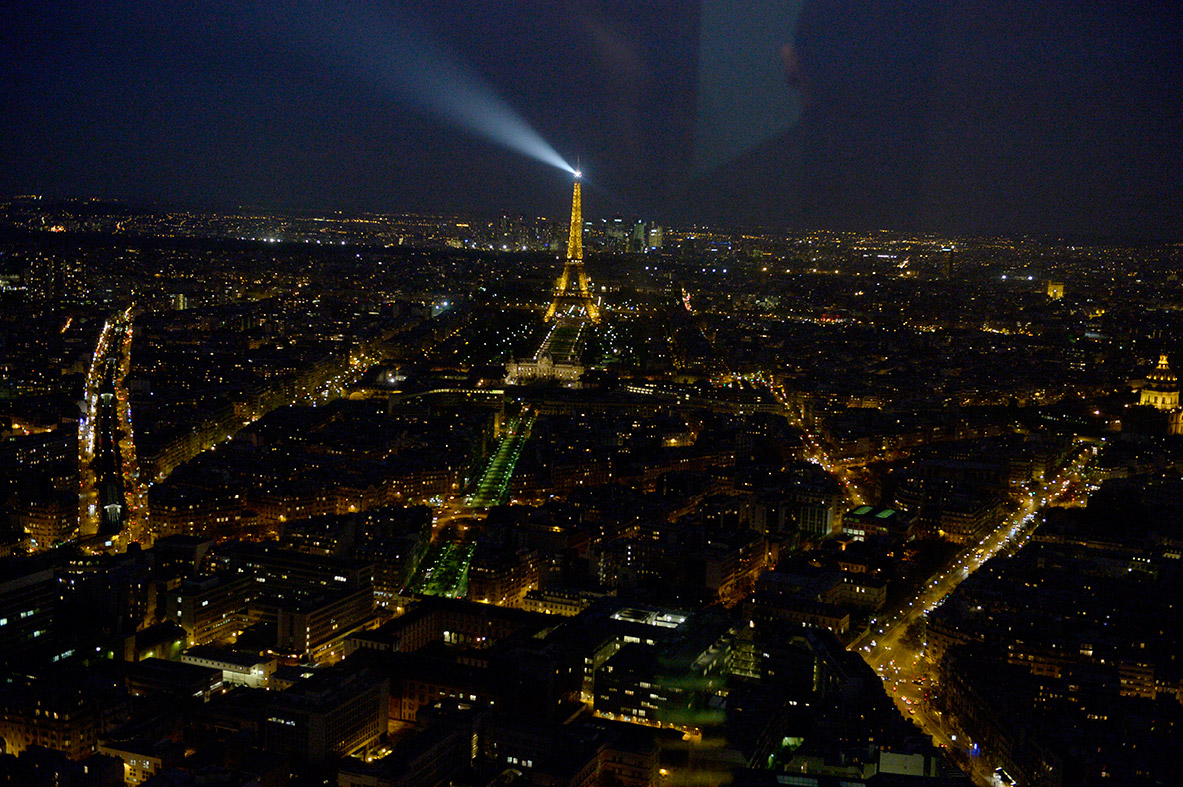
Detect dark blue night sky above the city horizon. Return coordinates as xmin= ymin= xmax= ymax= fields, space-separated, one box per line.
xmin=0 ymin=0 xmax=1183 ymax=238
